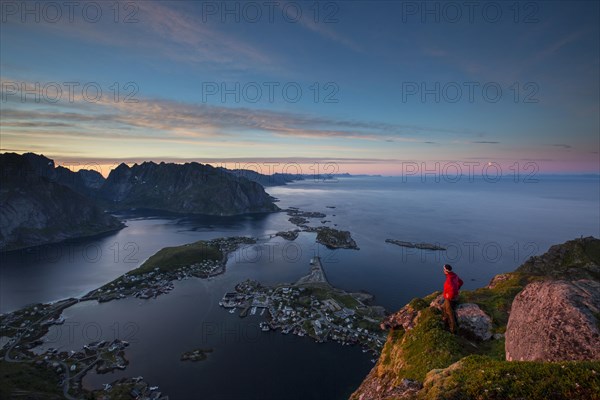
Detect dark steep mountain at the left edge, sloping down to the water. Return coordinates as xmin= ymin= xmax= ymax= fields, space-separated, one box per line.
xmin=0 ymin=153 xmax=123 ymax=251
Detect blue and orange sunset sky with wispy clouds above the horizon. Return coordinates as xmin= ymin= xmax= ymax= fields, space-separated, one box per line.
xmin=0 ymin=1 xmax=600 ymax=175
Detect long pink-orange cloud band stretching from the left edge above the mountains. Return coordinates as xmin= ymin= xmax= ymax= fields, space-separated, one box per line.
xmin=1 ymin=77 xmax=477 ymax=143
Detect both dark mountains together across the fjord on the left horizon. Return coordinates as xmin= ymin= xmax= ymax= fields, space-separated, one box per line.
xmin=0 ymin=153 xmax=280 ymax=251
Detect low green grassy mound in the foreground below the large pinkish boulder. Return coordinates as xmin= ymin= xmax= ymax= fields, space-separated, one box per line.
xmin=418 ymin=356 xmax=600 ymax=400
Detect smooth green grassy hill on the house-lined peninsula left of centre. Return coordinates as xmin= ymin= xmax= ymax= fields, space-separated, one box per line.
xmin=130 ymin=241 xmax=223 ymax=275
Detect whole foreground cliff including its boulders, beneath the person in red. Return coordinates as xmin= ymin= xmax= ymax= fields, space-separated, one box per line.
xmin=351 ymin=237 xmax=600 ymax=400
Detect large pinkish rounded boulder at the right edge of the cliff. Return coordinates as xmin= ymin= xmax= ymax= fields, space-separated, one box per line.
xmin=506 ymin=280 xmax=600 ymax=361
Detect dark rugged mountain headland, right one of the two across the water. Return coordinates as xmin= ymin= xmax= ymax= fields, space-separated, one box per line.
xmin=99 ymin=162 xmax=278 ymax=215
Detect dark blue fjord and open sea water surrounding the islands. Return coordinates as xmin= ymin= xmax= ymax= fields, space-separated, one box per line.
xmin=0 ymin=177 xmax=600 ymax=399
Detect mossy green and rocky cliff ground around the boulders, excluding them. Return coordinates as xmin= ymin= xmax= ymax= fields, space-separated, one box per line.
xmin=351 ymin=238 xmax=600 ymax=400
